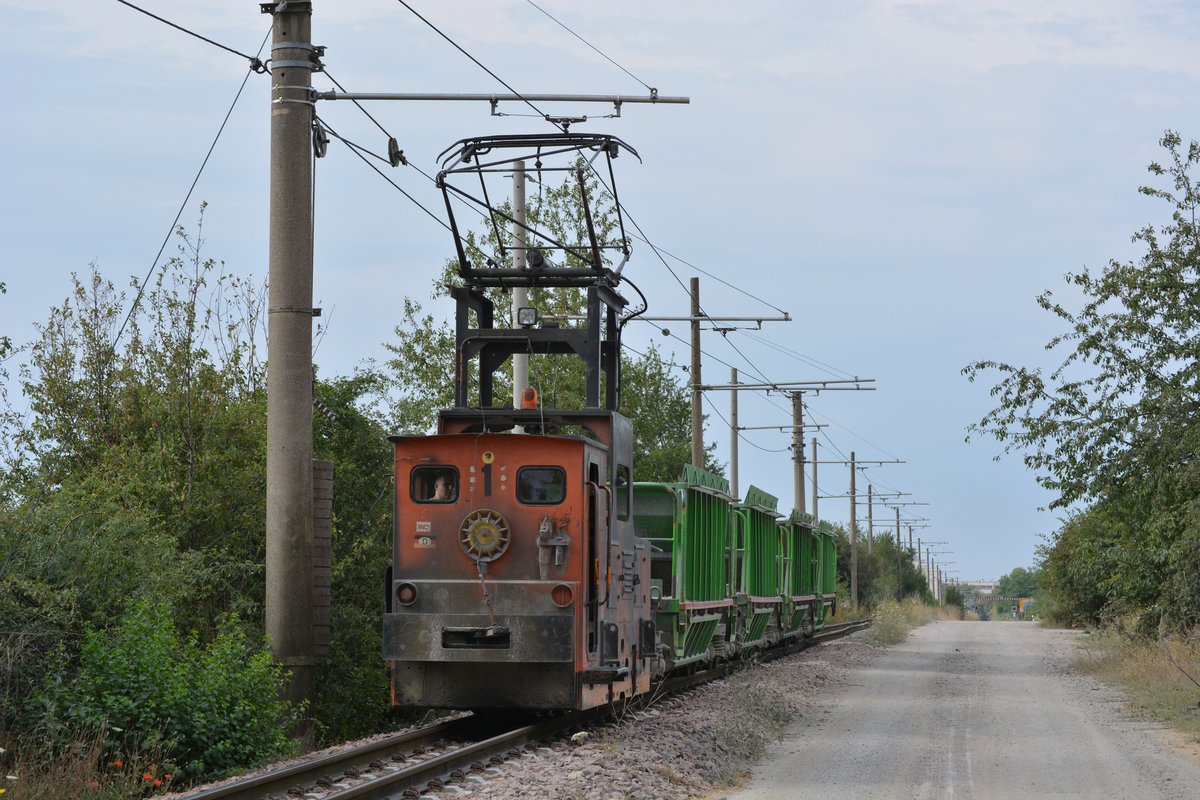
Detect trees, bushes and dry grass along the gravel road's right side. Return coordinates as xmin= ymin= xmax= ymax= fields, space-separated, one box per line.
xmin=964 ymin=131 xmax=1200 ymax=734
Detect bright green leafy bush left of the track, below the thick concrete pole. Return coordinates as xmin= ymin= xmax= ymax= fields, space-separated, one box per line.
xmin=44 ymin=600 xmax=299 ymax=778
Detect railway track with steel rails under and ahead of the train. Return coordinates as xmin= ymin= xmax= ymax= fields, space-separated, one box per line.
xmin=185 ymin=619 xmax=871 ymax=800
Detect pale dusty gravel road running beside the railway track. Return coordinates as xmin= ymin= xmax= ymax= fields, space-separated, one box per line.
xmin=713 ymin=621 xmax=1200 ymax=800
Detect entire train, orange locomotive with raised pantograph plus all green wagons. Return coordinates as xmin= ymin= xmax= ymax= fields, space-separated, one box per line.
xmin=383 ymin=133 xmax=835 ymax=710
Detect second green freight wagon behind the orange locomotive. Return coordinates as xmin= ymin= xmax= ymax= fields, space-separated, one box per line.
xmin=733 ymin=486 xmax=784 ymax=649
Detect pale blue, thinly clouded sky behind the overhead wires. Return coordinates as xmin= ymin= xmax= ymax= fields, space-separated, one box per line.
xmin=0 ymin=0 xmax=1200 ymax=581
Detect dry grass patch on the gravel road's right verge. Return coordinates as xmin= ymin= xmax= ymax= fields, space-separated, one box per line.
xmin=1076 ymin=633 xmax=1200 ymax=741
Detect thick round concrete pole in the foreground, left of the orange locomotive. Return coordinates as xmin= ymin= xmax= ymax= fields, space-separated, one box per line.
xmin=264 ymin=2 xmax=317 ymax=741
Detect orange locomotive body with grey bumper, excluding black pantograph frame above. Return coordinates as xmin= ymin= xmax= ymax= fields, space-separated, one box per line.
xmin=384 ymin=402 xmax=654 ymax=709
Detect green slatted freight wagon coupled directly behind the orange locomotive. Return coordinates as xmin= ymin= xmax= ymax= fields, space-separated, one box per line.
xmin=634 ymin=465 xmax=733 ymax=669
